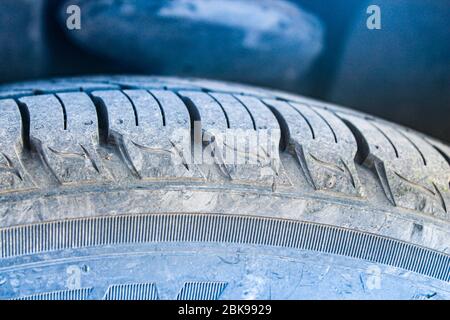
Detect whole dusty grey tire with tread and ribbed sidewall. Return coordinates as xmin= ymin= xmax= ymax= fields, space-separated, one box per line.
xmin=0 ymin=76 xmax=450 ymax=299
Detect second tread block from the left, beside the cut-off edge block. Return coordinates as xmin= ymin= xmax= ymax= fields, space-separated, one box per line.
xmin=20 ymin=92 xmax=107 ymax=184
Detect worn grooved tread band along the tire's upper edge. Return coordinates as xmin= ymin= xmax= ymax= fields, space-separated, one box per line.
xmin=0 ymin=77 xmax=450 ymax=219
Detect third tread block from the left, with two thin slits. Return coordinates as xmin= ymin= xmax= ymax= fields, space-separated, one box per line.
xmin=92 ymin=90 xmax=203 ymax=179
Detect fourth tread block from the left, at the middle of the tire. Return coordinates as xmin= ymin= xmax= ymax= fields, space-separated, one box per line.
xmin=180 ymin=91 xmax=289 ymax=185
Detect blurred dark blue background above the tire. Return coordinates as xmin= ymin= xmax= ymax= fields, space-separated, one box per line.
xmin=0 ymin=0 xmax=450 ymax=142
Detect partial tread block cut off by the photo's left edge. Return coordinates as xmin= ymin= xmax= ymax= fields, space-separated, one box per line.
xmin=0 ymin=100 xmax=34 ymax=193
